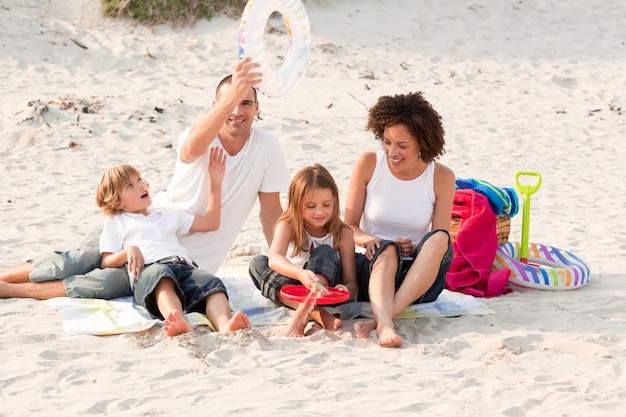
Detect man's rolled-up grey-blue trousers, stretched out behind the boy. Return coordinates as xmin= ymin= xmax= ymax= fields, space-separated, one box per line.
xmin=29 ymin=228 xmax=133 ymax=300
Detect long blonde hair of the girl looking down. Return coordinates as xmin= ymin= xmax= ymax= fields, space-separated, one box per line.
xmin=278 ymin=164 xmax=348 ymax=256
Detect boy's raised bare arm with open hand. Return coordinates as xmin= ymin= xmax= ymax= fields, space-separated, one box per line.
xmin=189 ymin=147 xmax=226 ymax=232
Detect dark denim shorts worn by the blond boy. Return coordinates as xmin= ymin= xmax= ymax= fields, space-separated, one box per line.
xmin=133 ymin=262 xmax=228 ymax=320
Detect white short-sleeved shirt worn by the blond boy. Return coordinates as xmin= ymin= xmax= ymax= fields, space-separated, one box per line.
xmin=100 ymin=206 xmax=194 ymax=265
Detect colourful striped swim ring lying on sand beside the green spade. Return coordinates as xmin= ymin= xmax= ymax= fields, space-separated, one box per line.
xmin=492 ymin=242 xmax=591 ymax=290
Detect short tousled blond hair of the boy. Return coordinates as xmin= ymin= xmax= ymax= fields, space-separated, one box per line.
xmin=96 ymin=164 xmax=141 ymax=216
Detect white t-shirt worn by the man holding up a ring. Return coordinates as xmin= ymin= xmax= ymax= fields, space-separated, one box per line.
xmin=156 ymin=128 xmax=289 ymax=274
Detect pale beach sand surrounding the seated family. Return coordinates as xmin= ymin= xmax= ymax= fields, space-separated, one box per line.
xmin=0 ymin=0 xmax=626 ymax=417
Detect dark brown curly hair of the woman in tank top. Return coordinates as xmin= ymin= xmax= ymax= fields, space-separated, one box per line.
xmin=365 ymin=91 xmax=445 ymax=162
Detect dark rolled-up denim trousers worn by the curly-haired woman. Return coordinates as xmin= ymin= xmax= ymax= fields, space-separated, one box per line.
xmin=356 ymin=229 xmax=454 ymax=304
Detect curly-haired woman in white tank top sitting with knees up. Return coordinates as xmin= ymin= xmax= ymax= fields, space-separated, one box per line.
xmin=345 ymin=92 xmax=455 ymax=347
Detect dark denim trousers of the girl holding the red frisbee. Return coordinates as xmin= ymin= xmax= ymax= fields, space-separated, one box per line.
xmin=248 ymin=245 xmax=342 ymax=306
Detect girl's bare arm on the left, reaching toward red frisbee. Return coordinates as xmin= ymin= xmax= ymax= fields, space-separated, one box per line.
xmin=268 ymin=220 xmax=318 ymax=289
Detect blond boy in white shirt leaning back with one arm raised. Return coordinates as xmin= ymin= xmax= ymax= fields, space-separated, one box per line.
xmin=96 ymin=147 xmax=250 ymax=336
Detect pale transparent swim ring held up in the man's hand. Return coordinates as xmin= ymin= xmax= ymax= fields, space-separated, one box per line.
xmin=239 ymin=0 xmax=311 ymax=97
